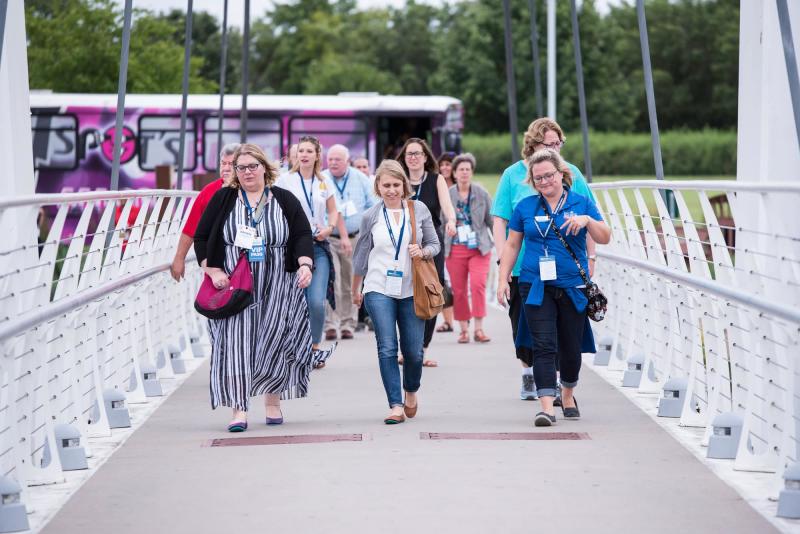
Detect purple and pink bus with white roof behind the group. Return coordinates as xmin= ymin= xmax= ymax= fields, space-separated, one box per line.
xmin=31 ymin=92 xmax=463 ymax=193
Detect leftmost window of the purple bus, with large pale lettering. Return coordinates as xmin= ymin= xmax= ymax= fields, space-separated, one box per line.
xmin=31 ymin=114 xmax=78 ymax=170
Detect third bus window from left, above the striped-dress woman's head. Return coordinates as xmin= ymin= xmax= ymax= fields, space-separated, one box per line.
xmin=203 ymin=117 xmax=281 ymax=172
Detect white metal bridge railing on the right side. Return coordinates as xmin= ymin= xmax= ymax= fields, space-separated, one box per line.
xmin=592 ymin=181 xmax=800 ymax=504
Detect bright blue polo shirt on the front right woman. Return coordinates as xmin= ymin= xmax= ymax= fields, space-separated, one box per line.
xmin=508 ymin=191 xmax=603 ymax=312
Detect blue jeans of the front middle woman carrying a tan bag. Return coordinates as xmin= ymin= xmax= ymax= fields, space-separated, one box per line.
xmin=364 ymin=291 xmax=425 ymax=408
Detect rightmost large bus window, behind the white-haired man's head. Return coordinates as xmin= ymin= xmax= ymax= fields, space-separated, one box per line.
xmin=289 ymin=117 xmax=367 ymax=163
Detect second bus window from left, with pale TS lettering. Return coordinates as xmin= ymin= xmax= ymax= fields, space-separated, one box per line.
xmin=139 ymin=115 xmax=197 ymax=171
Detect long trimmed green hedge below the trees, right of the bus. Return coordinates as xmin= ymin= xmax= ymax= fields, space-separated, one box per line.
xmin=462 ymin=129 xmax=736 ymax=176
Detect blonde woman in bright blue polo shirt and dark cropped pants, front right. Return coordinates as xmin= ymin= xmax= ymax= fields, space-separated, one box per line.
xmin=497 ymin=149 xmax=611 ymax=426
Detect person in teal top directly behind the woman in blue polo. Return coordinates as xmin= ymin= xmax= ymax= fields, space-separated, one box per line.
xmin=492 ymin=117 xmax=595 ymax=400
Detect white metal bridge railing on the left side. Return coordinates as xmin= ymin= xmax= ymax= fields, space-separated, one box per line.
xmin=0 ymin=190 xmax=206 ymax=510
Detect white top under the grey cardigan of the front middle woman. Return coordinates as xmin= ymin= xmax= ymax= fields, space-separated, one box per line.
xmin=364 ymin=207 xmax=414 ymax=299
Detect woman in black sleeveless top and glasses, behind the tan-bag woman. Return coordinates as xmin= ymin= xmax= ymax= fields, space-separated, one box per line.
xmin=397 ymin=137 xmax=456 ymax=367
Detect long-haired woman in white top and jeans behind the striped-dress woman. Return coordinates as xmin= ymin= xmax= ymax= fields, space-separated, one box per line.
xmin=276 ymin=135 xmax=339 ymax=356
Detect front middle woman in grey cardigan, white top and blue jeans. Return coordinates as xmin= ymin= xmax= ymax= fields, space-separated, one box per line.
xmin=352 ymin=160 xmax=440 ymax=425
